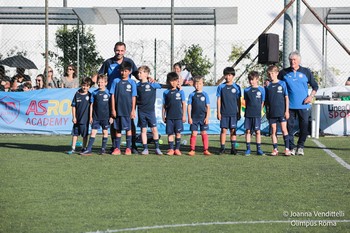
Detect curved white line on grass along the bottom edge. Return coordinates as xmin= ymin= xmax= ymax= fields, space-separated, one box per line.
xmin=87 ymin=219 xmax=350 ymax=233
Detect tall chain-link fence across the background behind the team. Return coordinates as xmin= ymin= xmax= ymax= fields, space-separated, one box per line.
xmin=0 ymin=0 xmax=350 ymax=86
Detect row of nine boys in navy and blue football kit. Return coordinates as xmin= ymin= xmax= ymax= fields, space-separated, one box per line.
xmin=68 ymin=62 xmax=290 ymax=156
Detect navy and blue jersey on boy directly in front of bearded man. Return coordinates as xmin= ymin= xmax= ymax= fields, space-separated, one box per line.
xmin=110 ymin=78 xmax=137 ymax=117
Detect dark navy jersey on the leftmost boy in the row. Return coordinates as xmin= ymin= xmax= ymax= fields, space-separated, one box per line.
xmin=71 ymin=89 xmax=91 ymax=125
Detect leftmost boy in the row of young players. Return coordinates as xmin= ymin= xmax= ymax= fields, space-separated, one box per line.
xmin=67 ymin=78 xmax=92 ymax=155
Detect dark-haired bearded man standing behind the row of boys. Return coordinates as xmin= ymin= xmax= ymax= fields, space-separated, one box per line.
xmin=98 ymin=41 xmax=139 ymax=154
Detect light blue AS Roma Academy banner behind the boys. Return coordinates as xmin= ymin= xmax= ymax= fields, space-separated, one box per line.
xmin=0 ymin=86 xmax=269 ymax=135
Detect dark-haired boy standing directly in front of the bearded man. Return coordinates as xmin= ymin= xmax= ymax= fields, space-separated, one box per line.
xmin=111 ymin=61 xmax=137 ymax=155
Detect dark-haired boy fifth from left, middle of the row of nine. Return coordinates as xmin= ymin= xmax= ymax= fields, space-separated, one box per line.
xmin=162 ymin=72 xmax=186 ymax=155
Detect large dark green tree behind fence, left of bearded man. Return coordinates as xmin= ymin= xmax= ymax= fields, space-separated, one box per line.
xmin=44 ymin=26 xmax=104 ymax=76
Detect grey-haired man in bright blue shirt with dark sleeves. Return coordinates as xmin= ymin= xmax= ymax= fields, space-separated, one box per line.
xmin=278 ymin=51 xmax=318 ymax=155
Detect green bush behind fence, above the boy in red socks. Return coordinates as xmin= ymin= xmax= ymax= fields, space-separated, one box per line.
xmin=182 ymin=44 xmax=213 ymax=81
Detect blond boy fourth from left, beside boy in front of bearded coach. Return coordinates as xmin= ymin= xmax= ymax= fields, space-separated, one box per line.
xmin=136 ymin=66 xmax=163 ymax=155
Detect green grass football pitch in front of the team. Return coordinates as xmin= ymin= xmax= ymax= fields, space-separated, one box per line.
xmin=0 ymin=135 xmax=350 ymax=233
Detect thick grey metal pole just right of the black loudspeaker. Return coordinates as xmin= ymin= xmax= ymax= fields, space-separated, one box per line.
xmin=283 ymin=0 xmax=293 ymax=68
